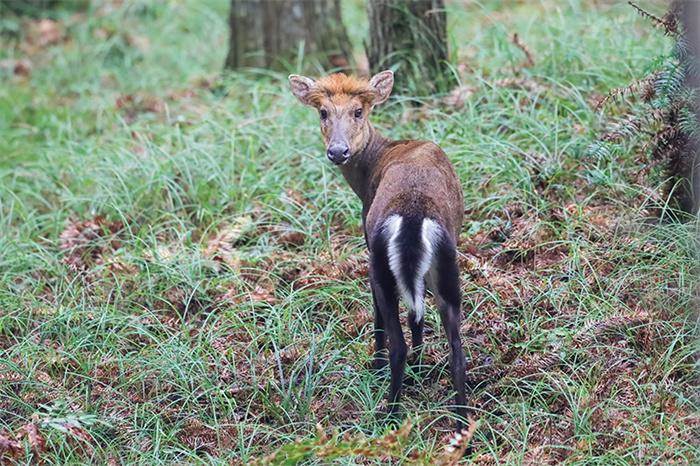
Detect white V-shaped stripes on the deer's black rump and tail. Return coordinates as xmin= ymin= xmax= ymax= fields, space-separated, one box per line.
xmin=384 ymin=215 xmax=440 ymax=322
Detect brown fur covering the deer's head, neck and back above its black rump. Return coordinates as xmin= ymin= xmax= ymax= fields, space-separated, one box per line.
xmin=293 ymin=73 xmax=463 ymax=237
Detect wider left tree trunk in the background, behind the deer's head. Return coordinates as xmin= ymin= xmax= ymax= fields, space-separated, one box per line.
xmin=226 ymin=0 xmax=350 ymax=70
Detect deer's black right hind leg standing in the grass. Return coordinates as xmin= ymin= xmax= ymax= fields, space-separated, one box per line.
xmin=437 ymin=244 xmax=467 ymax=430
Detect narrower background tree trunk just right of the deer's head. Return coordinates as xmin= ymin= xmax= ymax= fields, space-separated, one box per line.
xmin=367 ymin=0 xmax=456 ymax=95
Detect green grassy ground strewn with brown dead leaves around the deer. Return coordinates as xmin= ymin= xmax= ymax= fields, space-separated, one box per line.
xmin=0 ymin=0 xmax=698 ymax=464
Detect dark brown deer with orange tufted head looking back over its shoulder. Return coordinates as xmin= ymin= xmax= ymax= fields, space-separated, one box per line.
xmin=289 ymin=70 xmax=467 ymax=430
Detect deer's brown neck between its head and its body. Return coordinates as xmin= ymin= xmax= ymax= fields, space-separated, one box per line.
xmin=340 ymin=124 xmax=391 ymax=205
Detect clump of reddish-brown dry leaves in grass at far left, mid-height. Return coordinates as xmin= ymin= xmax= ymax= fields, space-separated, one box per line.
xmin=59 ymin=215 xmax=123 ymax=272
